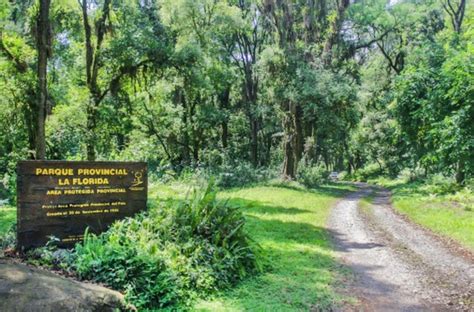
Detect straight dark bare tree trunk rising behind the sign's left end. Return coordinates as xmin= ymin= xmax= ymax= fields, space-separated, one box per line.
xmin=33 ymin=0 xmax=51 ymax=159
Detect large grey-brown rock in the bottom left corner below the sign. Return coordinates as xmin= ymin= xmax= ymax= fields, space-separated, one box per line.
xmin=0 ymin=260 xmax=125 ymax=312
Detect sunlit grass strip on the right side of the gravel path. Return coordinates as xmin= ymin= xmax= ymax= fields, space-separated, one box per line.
xmin=372 ymin=180 xmax=474 ymax=251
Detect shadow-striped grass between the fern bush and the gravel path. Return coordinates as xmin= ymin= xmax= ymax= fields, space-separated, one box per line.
xmin=194 ymin=182 xmax=354 ymax=311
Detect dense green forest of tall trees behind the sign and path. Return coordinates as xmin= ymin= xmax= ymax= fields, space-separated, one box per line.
xmin=0 ymin=0 xmax=468 ymax=187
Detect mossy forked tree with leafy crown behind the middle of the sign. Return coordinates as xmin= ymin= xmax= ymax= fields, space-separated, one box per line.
xmin=79 ymin=0 xmax=169 ymax=160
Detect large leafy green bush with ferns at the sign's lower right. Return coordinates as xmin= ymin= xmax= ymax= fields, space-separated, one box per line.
xmin=74 ymin=183 xmax=259 ymax=309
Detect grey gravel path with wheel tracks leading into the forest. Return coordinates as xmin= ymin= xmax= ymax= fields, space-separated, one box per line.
xmin=329 ymin=184 xmax=474 ymax=311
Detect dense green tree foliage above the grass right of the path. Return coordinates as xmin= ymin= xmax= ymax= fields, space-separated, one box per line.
xmin=346 ymin=3 xmax=474 ymax=184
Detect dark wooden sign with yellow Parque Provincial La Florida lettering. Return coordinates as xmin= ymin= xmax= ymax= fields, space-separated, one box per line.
xmin=17 ymin=160 xmax=147 ymax=249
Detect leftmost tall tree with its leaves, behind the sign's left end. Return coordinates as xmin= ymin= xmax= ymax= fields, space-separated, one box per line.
xmin=0 ymin=0 xmax=52 ymax=159
